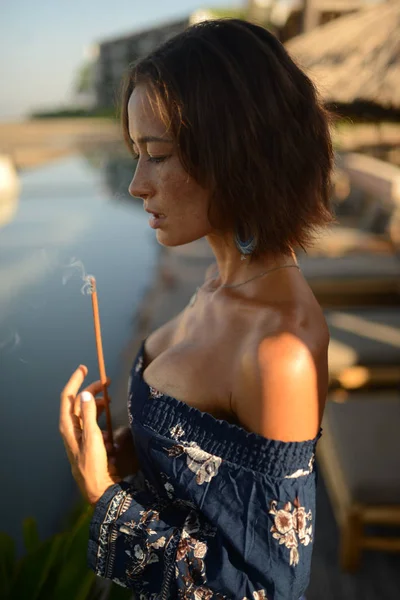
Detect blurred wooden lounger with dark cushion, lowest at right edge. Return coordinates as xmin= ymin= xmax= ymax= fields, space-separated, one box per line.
xmin=317 ymin=392 xmax=400 ymax=570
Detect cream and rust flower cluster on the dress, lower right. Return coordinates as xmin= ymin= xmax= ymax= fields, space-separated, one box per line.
xmin=269 ymin=498 xmax=312 ymax=566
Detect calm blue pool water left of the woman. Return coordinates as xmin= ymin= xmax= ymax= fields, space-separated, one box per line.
xmin=0 ymin=148 xmax=159 ymax=542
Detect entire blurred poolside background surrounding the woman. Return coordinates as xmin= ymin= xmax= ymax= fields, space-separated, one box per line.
xmin=0 ymin=0 xmax=400 ymax=600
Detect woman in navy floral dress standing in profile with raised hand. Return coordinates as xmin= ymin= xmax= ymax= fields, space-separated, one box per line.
xmin=60 ymin=20 xmax=332 ymax=600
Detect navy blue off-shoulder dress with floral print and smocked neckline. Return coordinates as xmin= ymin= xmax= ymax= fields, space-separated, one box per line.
xmin=88 ymin=340 xmax=321 ymax=600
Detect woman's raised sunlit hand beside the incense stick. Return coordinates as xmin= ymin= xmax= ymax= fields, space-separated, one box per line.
xmin=60 ymin=365 xmax=121 ymax=505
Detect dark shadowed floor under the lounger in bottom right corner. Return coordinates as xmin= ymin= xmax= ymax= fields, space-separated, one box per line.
xmin=306 ymin=476 xmax=400 ymax=600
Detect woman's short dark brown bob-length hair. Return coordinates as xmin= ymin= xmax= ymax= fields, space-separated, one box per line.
xmin=121 ymin=19 xmax=333 ymax=258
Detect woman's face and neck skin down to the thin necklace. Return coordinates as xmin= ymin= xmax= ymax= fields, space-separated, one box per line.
xmin=127 ymin=85 xmax=272 ymax=285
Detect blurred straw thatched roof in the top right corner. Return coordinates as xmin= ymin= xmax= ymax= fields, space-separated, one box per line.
xmin=285 ymin=0 xmax=400 ymax=108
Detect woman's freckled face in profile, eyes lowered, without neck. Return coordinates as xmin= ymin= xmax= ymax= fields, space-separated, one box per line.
xmin=128 ymin=85 xmax=216 ymax=246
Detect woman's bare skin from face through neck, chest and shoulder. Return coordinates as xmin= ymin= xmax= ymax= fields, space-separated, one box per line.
xmin=128 ymin=85 xmax=329 ymax=441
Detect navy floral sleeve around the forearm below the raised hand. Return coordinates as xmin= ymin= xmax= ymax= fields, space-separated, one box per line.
xmin=88 ymin=481 xmax=198 ymax=600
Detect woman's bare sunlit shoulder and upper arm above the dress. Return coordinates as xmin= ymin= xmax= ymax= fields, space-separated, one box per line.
xmin=232 ymin=310 xmax=329 ymax=441
